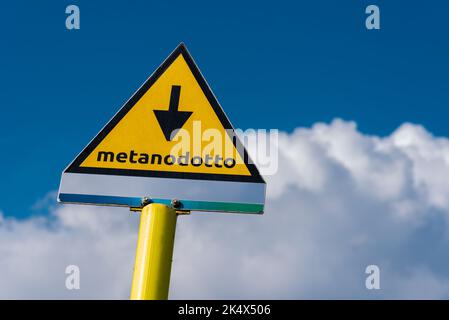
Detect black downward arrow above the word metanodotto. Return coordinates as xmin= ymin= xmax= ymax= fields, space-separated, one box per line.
xmin=154 ymin=86 xmax=193 ymax=141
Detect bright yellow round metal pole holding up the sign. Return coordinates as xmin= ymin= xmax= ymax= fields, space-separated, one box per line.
xmin=130 ymin=203 xmax=176 ymax=300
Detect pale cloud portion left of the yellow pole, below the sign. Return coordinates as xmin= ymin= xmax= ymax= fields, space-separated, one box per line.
xmin=0 ymin=206 xmax=138 ymax=299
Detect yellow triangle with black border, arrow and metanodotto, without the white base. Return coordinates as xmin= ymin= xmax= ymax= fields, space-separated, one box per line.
xmin=68 ymin=44 xmax=261 ymax=182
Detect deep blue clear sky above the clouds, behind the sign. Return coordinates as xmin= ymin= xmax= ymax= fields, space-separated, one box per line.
xmin=0 ymin=0 xmax=449 ymax=217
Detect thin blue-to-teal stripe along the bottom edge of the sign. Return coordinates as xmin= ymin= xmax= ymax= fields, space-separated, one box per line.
xmin=58 ymin=193 xmax=264 ymax=214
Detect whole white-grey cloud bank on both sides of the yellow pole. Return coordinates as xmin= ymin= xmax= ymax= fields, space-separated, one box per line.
xmin=0 ymin=120 xmax=449 ymax=299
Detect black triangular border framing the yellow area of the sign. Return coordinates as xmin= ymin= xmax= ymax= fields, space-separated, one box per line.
xmin=64 ymin=43 xmax=265 ymax=183
